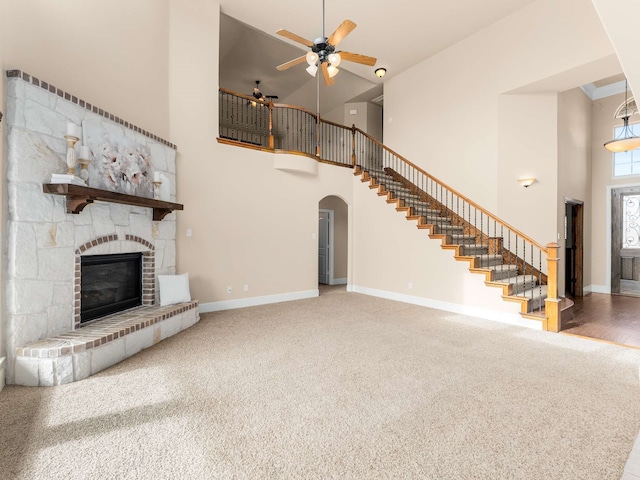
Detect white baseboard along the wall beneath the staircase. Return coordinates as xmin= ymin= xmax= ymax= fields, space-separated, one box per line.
xmin=347 ymin=285 xmax=542 ymax=330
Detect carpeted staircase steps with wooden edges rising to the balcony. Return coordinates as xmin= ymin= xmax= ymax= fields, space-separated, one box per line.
xmin=354 ymin=166 xmax=547 ymax=320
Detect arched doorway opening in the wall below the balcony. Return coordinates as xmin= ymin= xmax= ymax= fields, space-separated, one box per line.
xmin=318 ymin=195 xmax=348 ymax=288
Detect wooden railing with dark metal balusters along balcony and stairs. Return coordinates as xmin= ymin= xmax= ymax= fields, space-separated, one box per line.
xmin=219 ymin=89 xmax=559 ymax=331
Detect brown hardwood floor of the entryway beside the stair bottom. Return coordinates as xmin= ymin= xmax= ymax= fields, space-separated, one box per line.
xmin=562 ymin=293 xmax=640 ymax=348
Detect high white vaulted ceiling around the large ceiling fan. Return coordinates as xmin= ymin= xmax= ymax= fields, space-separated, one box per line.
xmin=220 ymin=0 xmax=616 ymax=114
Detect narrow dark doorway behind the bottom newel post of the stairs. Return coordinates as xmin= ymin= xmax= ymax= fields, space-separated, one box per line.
xmin=564 ymin=200 xmax=584 ymax=298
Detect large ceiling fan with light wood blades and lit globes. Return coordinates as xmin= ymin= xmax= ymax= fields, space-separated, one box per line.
xmin=276 ymin=0 xmax=377 ymax=85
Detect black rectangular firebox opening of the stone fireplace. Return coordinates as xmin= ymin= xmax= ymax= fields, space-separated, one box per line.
xmin=80 ymin=253 xmax=142 ymax=324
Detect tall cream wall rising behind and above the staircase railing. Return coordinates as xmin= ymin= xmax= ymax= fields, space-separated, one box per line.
xmin=384 ymin=0 xmax=613 ymax=233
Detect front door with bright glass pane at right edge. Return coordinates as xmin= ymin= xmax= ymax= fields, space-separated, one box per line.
xmin=611 ymin=187 xmax=640 ymax=295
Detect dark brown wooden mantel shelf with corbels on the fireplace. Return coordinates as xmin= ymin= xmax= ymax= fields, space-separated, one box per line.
xmin=42 ymin=183 xmax=184 ymax=221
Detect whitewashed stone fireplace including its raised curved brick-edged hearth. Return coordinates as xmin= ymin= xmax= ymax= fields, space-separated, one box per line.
xmin=4 ymin=70 xmax=197 ymax=385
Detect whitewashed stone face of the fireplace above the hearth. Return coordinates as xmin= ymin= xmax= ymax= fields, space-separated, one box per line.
xmin=3 ymin=70 xmax=176 ymax=383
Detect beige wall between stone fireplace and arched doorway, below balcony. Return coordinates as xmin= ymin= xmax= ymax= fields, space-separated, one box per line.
xmin=170 ymin=0 xmax=352 ymax=304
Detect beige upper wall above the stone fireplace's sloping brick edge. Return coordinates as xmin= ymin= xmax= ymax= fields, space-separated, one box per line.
xmin=0 ymin=0 xmax=169 ymax=138
